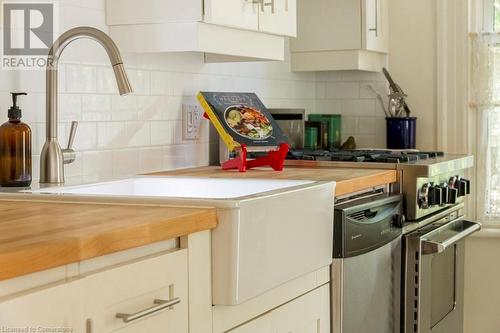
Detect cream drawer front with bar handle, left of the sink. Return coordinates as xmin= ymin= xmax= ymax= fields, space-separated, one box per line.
xmin=85 ymin=250 xmax=188 ymax=333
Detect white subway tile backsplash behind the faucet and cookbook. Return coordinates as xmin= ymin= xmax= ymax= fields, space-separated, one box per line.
xmin=0 ymin=0 xmax=385 ymax=181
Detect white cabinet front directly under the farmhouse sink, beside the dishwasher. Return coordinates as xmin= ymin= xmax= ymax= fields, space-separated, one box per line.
xmin=230 ymin=284 xmax=330 ymax=333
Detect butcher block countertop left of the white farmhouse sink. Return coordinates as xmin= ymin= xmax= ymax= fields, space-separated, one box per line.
xmin=0 ymin=200 xmax=217 ymax=281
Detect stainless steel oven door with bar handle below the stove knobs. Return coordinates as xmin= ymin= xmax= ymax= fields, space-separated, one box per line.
xmin=402 ymin=204 xmax=481 ymax=333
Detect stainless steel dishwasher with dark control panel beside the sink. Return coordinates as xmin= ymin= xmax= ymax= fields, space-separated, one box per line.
xmin=331 ymin=194 xmax=404 ymax=333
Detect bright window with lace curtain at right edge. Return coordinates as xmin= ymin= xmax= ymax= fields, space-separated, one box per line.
xmin=471 ymin=0 xmax=500 ymax=222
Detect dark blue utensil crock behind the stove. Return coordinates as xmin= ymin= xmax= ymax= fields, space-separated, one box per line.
xmin=385 ymin=117 xmax=417 ymax=149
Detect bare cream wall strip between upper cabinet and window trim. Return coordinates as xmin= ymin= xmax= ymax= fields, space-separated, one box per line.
xmin=389 ymin=0 xmax=437 ymax=150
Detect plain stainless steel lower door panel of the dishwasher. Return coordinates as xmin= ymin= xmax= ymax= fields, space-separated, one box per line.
xmin=332 ymin=238 xmax=401 ymax=333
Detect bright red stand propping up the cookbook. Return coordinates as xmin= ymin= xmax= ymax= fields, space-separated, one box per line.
xmin=203 ymin=113 xmax=290 ymax=172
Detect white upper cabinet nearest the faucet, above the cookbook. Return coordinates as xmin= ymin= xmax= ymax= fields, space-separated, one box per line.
xmin=106 ymin=0 xmax=297 ymax=61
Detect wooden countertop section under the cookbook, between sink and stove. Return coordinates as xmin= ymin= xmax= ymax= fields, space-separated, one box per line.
xmin=150 ymin=167 xmax=398 ymax=196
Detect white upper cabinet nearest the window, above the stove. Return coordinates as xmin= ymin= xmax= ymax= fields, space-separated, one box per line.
xmin=291 ymin=0 xmax=389 ymax=71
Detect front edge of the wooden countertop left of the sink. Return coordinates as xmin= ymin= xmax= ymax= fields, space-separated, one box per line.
xmin=0 ymin=202 xmax=217 ymax=281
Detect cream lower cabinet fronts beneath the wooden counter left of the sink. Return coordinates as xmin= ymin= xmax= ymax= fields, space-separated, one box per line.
xmin=0 ymin=249 xmax=189 ymax=333
